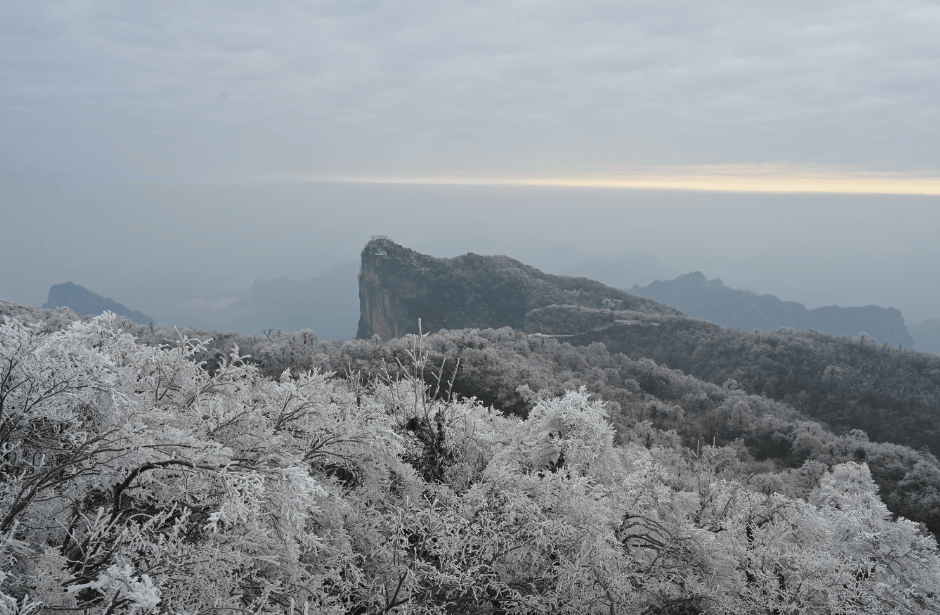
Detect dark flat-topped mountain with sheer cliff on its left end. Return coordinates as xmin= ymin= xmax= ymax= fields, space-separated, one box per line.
xmin=356 ymin=239 xmax=680 ymax=339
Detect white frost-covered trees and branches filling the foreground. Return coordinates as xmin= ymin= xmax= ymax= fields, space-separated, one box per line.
xmin=0 ymin=315 xmax=940 ymax=615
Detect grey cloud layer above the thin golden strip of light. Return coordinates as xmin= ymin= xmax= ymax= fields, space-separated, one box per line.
xmin=0 ymin=0 xmax=940 ymax=178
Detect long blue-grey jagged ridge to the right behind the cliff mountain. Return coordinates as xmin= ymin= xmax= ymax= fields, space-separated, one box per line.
xmin=631 ymin=271 xmax=914 ymax=348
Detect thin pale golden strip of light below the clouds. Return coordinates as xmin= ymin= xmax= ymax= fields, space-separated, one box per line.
xmin=320 ymin=165 xmax=940 ymax=196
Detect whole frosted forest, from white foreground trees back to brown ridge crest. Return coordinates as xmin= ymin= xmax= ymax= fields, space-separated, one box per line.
xmin=0 ymin=302 xmax=940 ymax=615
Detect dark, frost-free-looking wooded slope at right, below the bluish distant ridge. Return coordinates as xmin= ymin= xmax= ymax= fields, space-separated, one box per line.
xmin=566 ymin=318 xmax=940 ymax=454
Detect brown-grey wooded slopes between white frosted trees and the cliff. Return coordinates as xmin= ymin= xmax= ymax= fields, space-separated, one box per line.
xmin=7 ymin=302 xmax=940 ymax=533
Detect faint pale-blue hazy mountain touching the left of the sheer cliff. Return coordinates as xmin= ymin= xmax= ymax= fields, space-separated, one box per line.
xmin=218 ymin=261 xmax=359 ymax=340
